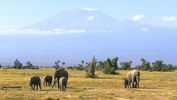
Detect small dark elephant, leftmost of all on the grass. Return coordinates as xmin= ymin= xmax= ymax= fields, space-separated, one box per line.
xmin=29 ymin=76 xmax=41 ymax=90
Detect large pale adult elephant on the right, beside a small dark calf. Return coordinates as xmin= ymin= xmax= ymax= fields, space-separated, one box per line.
xmin=127 ymin=70 xmax=140 ymax=88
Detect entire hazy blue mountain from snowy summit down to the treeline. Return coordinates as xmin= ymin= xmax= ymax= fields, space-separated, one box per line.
xmin=0 ymin=8 xmax=177 ymax=65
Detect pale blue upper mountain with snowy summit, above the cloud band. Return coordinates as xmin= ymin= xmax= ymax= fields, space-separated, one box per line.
xmin=27 ymin=8 xmax=150 ymax=32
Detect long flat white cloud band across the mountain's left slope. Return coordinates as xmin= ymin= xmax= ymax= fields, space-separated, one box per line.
xmin=0 ymin=28 xmax=86 ymax=35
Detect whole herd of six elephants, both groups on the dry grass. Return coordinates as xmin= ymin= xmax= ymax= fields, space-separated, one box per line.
xmin=29 ymin=68 xmax=140 ymax=91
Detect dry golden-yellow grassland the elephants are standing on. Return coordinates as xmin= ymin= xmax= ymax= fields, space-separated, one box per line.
xmin=0 ymin=68 xmax=177 ymax=100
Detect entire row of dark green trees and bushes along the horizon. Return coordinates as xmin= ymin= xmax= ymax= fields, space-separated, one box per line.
xmin=0 ymin=57 xmax=177 ymax=74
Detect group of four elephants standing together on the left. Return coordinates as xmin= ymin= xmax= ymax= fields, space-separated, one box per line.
xmin=29 ymin=68 xmax=68 ymax=91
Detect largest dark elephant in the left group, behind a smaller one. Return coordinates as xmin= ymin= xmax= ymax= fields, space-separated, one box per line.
xmin=52 ymin=68 xmax=68 ymax=89
